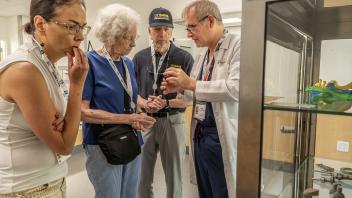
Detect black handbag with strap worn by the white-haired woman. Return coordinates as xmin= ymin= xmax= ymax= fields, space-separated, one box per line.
xmin=91 ymin=60 xmax=141 ymax=165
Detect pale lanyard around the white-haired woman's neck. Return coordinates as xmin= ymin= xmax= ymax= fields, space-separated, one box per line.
xmin=102 ymin=46 xmax=136 ymax=110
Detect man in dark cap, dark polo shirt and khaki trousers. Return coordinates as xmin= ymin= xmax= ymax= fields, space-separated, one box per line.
xmin=133 ymin=8 xmax=193 ymax=198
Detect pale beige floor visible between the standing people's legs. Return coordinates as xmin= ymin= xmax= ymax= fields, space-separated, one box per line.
xmin=67 ymin=146 xmax=198 ymax=198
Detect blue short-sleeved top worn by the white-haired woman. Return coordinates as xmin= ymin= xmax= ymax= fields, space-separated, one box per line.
xmin=82 ymin=51 xmax=142 ymax=144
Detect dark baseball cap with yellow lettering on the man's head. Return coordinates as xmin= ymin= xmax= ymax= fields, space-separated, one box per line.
xmin=149 ymin=7 xmax=174 ymax=28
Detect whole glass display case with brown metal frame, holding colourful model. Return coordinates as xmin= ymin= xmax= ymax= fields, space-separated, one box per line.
xmin=237 ymin=0 xmax=352 ymax=198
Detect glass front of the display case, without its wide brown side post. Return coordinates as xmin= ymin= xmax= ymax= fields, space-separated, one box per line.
xmin=260 ymin=0 xmax=352 ymax=198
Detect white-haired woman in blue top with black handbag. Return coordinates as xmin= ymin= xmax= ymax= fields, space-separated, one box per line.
xmin=81 ymin=4 xmax=155 ymax=198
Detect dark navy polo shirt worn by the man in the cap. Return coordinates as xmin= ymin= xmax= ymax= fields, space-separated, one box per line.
xmin=133 ymin=42 xmax=194 ymax=112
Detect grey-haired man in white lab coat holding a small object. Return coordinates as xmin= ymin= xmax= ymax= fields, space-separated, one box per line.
xmin=161 ymin=0 xmax=240 ymax=198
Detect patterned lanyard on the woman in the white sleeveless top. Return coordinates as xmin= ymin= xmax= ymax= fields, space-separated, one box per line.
xmin=32 ymin=37 xmax=68 ymax=99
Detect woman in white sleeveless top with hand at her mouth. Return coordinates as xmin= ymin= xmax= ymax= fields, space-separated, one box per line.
xmin=0 ymin=0 xmax=90 ymax=198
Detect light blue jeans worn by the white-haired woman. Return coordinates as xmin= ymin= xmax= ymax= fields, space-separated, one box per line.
xmin=84 ymin=145 xmax=141 ymax=198
